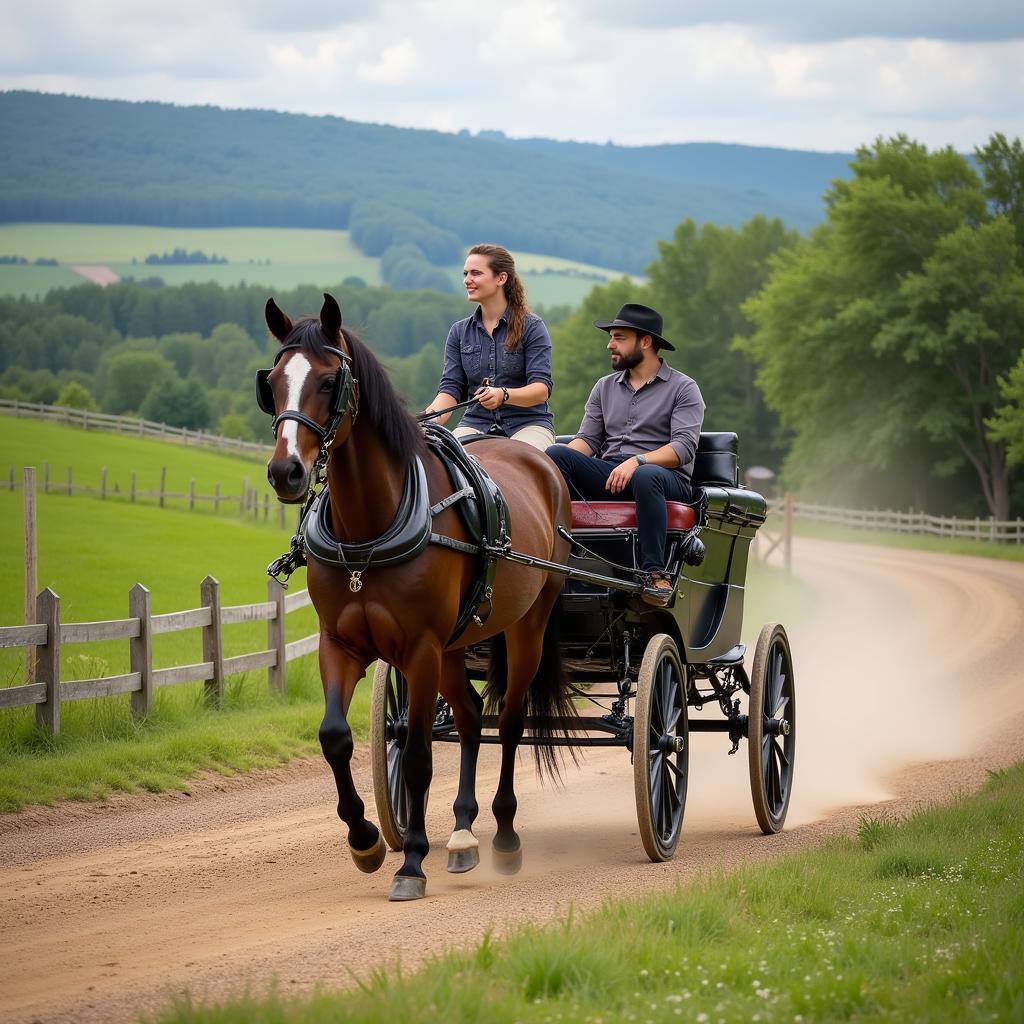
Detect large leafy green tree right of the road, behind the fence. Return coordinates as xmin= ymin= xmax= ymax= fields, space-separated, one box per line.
xmin=745 ymin=136 xmax=1024 ymax=518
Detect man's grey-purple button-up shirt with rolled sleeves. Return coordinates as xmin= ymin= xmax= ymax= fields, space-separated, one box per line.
xmin=577 ymin=359 xmax=705 ymax=480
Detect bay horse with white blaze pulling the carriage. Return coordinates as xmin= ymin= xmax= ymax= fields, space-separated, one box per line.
xmin=257 ymin=294 xmax=574 ymax=900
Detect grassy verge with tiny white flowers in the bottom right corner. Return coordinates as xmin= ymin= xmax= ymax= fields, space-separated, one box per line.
xmin=151 ymin=765 xmax=1024 ymax=1024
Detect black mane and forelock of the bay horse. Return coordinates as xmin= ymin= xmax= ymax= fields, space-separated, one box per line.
xmin=287 ymin=316 xmax=427 ymax=463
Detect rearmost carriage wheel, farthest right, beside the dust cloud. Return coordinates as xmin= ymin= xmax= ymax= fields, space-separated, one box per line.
xmin=746 ymin=623 xmax=797 ymax=836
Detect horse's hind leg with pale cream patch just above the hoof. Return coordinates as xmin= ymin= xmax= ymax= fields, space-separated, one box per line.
xmin=441 ymin=650 xmax=483 ymax=874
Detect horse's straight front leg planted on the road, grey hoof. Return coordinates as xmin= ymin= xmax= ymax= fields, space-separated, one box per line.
xmin=389 ymin=640 xmax=441 ymax=901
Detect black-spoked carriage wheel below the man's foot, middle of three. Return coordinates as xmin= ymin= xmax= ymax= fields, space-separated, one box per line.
xmin=633 ymin=633 xmax=690 ymax=861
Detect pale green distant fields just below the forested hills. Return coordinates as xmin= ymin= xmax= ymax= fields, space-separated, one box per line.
xmin=0 ymin=223 xmax=621 ymax=306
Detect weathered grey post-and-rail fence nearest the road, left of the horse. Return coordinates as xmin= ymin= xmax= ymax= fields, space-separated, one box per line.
xmin=0 ymin=577 xmax=319 ymax=735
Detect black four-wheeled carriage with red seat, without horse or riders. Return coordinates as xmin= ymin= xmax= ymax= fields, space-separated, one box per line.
xmin=371 ymin=432 xmax=796 ymax=861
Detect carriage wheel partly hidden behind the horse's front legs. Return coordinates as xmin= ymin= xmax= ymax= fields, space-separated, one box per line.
xmin=370 ymin=660 xmax=409 ymax=850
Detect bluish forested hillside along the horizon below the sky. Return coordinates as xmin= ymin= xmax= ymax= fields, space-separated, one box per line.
xmin=0 ymin=92 xmax=831 ymax=276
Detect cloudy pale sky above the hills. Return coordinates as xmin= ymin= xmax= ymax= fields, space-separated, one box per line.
xmin=0 ymin=0 xmax=1024 ymax=152
